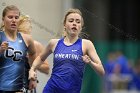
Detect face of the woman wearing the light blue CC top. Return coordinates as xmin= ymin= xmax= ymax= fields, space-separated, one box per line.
xmin=3 ymin=10 xmax=19 ymax=31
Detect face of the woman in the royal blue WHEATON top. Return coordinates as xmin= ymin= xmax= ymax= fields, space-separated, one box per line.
xmin=64 ymin=13 xmax=82 ymax=36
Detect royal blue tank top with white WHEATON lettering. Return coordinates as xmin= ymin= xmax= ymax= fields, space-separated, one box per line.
xmin=44 ymin=38 xmax=85 ymax=93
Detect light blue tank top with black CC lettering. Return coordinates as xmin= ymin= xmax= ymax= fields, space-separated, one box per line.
xmin=0 ymin=32 xmax=27 ymax=91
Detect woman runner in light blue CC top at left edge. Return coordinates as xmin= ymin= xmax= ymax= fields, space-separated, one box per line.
xmin=0 ymin=5 xmax=36 ymax=93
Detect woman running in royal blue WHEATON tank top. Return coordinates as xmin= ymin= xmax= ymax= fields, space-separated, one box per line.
xmin=29 ymin=9 xmax=105 ymax=93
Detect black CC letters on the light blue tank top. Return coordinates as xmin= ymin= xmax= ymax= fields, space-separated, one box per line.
xmin=4 ymin=47 xmax=23 ymax=62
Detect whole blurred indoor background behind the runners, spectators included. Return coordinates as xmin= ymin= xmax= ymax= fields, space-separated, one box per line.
xmin=0 ymin=0 xmax=140 ymax=93
